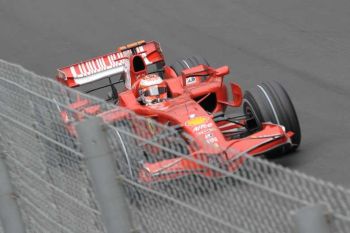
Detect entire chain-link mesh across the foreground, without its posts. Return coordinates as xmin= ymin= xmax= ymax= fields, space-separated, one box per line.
xmin=0 ymin=61 xmax=350 ymax=233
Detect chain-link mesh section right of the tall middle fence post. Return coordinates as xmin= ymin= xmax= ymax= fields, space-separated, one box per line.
xmin=108 ymin=112 xmax=350 ymax=233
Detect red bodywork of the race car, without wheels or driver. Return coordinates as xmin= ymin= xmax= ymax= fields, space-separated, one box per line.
xmin=57 ymin=41 xmax=293 ymax=182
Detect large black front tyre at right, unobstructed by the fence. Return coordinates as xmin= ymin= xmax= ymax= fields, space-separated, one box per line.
xmin=243 ymin=82 xmax=301 ymax=157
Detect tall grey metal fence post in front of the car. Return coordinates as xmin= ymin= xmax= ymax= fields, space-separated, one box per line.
xmin=77 ymin=117 xmax=133 ymax=233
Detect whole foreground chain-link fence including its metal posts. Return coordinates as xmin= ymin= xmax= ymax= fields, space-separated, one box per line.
xmin=0 ymin=61 xmax=350 ymax=233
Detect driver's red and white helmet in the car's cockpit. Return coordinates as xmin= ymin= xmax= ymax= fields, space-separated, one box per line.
xmin=138 ymin=74 xmax=168 ymax=105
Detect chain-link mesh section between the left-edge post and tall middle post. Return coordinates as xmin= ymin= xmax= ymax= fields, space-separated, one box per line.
xmin=0 ymin=62 xmax=112 ymax=233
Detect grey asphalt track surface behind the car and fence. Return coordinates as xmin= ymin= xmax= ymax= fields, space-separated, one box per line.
xmin=0 ymin=0 xmax=350 ymax=188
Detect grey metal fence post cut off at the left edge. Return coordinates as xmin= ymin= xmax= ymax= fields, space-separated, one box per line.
xmin=0 ymin=144 xmax=25 ymax=233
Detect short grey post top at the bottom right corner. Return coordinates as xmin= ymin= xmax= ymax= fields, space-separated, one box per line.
xmin=293 ymin=204 xmax=331 ymax=233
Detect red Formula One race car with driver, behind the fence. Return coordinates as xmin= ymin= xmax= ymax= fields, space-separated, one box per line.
xmin=56 ymin=41 xmax=301 ymax=182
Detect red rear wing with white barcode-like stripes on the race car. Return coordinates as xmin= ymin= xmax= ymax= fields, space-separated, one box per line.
xmin=56 ymin=41 xmax=164 ymax=89
